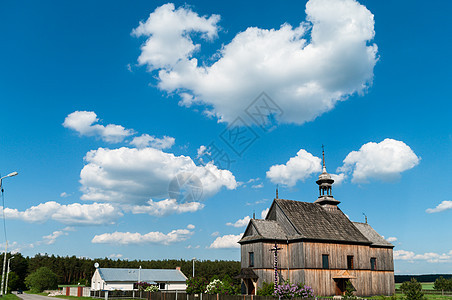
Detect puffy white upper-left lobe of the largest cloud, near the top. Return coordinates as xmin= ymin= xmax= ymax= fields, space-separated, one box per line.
xmin=132 ymin=3 xmax=220 ymax=70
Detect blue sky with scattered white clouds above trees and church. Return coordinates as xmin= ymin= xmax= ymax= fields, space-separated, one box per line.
xmin=0 ymin=0 xmax=452 ymax=274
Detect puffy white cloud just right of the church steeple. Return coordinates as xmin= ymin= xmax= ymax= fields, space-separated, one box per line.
xmin=338 ymin=139 xmax=420 ymax=183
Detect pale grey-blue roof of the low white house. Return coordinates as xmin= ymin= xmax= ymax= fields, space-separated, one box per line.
xmin=98 ymin=268 xmax=187 ymax=283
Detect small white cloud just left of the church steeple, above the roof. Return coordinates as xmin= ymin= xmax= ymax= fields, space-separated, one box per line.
xmin=267 ymin=149 xmax=322 ymax=187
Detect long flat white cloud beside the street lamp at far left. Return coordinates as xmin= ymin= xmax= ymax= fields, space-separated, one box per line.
xmin=5 ymin=201 xmax=123 ymax=225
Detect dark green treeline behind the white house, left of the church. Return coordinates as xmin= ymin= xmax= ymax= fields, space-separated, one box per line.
xmin=0 ymin=253 xmax=240 ymax=290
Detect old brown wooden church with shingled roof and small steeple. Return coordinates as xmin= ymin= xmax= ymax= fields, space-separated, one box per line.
xmin=238 ymin=151 xmax=394 ymax=296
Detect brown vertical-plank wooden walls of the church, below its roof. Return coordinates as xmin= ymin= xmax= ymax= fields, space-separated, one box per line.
xmin=241 ymin=242 xmax=394 ymax=296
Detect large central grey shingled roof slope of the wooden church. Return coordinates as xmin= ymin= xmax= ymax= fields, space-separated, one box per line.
xmin=275 ymin=199 xmax=370 ymax=244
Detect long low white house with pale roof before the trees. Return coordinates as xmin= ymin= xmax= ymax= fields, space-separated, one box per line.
xmin=91 ymin=268 xmax=187 ymax=291
